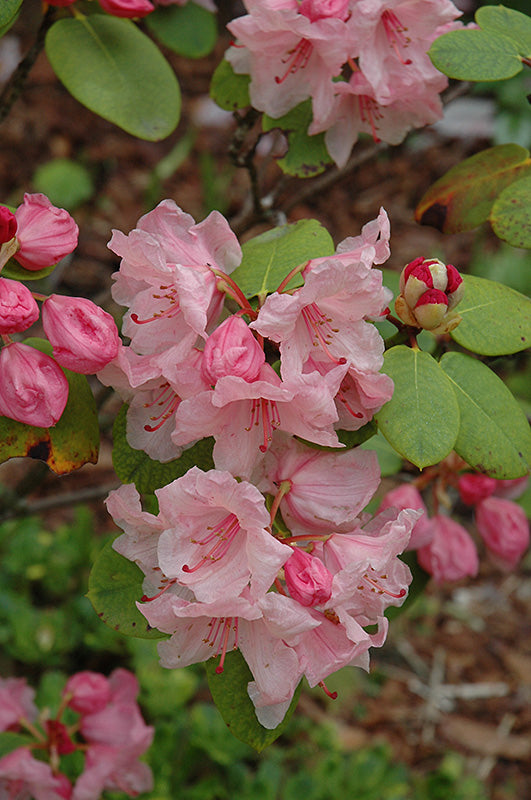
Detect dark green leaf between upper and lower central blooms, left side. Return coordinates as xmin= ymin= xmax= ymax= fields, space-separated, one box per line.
xmin=112 ymin=405 xmax=214 ymax=494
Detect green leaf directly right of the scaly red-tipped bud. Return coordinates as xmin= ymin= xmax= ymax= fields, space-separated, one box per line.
xmin=450 ymin=275 xmax=531 ymax=356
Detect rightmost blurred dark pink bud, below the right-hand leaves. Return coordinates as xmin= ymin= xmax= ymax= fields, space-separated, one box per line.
xmin=476 ymin=497 xmax=529 ymax=569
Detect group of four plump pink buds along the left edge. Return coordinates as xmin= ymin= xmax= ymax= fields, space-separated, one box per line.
xmin=0 ymin=194 xmax=119 ymax=428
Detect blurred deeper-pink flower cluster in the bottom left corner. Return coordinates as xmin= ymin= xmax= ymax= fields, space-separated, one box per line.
xmin=0 ymin=669 xmax=153 ymax=800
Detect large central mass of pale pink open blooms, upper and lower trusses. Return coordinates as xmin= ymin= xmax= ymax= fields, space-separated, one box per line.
xmin=98 ymin=200 xmax=418 ymax=728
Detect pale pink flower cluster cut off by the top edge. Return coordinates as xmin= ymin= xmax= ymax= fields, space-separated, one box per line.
xmin=226 ymin=0 xmax=461 ymax=166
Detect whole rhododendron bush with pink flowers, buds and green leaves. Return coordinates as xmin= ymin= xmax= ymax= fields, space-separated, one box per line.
xmin=0 ymin=0 xmax=531 ymax=788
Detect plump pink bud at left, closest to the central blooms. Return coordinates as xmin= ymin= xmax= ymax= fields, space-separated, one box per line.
xmin=42 ymin=294 xmax=120 ymax=375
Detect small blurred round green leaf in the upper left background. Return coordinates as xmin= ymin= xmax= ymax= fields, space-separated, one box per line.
xmin=33 ymin=158 xmax=94 ymax=211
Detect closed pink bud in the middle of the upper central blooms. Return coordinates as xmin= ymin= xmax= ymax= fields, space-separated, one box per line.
xmin=201 ymin=316 xmax=265 ymax=386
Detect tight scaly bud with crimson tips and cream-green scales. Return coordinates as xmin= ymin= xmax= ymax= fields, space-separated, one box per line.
xmin=395 ymin=257 xmax=465 ymax=334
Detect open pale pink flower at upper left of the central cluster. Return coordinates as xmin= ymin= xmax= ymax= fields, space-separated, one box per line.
xmin=109 ymin=200 xmax=241 ymax=361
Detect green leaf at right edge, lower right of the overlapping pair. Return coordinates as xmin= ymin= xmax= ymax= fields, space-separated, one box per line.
xmin=441 ymin=353 xmax=531 ymax=479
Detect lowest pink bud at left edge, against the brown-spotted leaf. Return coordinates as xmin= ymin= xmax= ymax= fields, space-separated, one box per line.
xmin=0 ymin=342 xmax=68 ymax=428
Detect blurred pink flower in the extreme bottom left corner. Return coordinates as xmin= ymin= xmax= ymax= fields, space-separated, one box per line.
xmin=0 ymin=747 xmax=72 ymax=800
